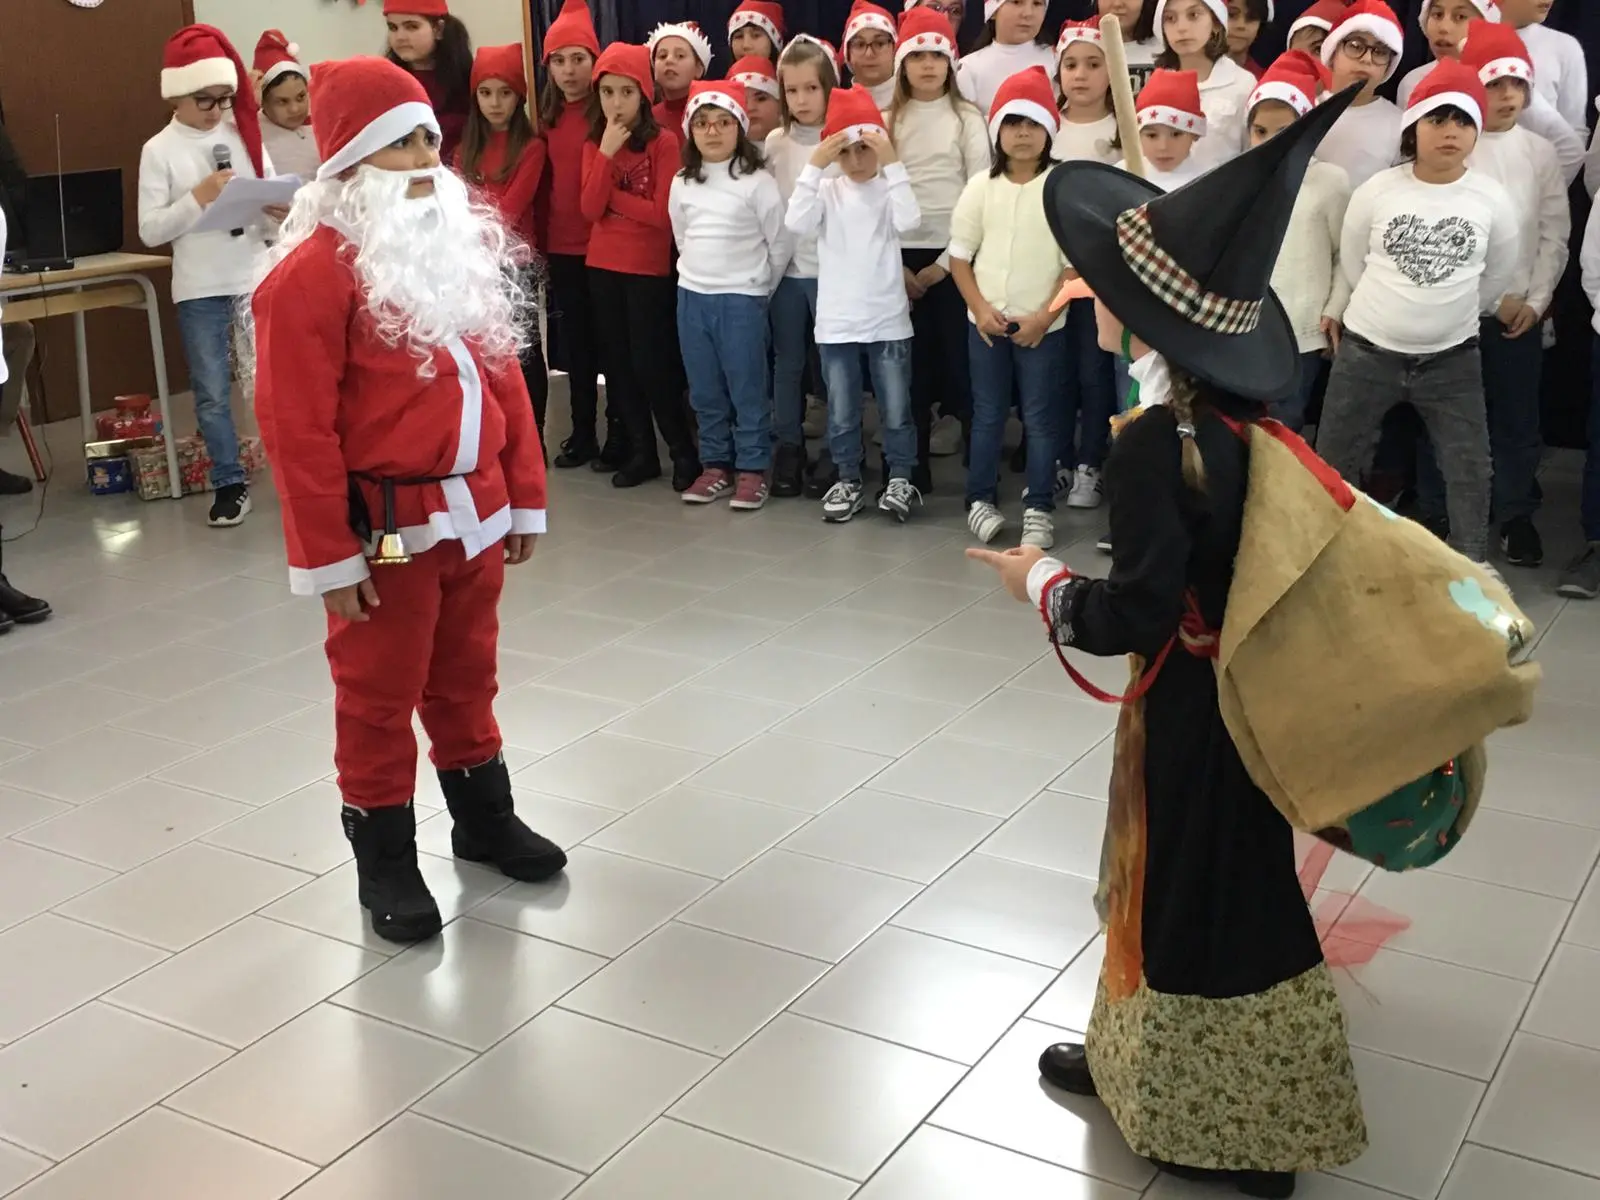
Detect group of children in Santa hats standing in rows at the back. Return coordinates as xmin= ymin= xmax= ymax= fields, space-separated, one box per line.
xmin=141 ymin=0 xmax=1600 ymax=595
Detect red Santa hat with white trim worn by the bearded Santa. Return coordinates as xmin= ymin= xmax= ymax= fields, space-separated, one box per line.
xmin=310 ymin=56 xmax=438 ymax=179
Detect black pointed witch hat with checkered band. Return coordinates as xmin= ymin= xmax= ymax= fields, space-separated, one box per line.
xmin=1045 ymin=86 xmax=1360 ymax=400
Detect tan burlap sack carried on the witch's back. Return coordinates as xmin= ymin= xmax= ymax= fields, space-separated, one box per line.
xmin=1216 ymin=426 xmax=1541 ymax=832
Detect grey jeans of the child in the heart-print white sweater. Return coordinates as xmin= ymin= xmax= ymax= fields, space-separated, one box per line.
xmin=1317 ymin=331 xmax=1491 ymax=562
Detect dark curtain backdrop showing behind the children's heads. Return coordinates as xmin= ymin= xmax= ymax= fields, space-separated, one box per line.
xmin=526 ymin=0 xmax=1600 ymax=448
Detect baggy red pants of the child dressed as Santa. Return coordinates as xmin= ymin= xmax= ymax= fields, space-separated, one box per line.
xmin=326 ymin=541 xmax=506 ymax=808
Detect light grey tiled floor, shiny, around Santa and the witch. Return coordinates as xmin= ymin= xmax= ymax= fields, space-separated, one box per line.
xmin=0 ymin=416 xmax=1600 ymax=1200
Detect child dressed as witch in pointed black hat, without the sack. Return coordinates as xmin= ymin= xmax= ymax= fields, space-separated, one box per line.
xmin=968 ymin=82 xmax=1366 ymax=1197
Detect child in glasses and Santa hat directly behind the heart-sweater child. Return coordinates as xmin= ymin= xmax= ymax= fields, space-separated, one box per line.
xmin=1317 ymin=0 xmax=1405 ymax=189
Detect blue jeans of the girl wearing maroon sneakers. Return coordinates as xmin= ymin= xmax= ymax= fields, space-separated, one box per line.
xmin=678 ymin=288 xmax=773 ymax=472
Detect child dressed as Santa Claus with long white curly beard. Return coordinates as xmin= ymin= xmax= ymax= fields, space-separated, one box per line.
xmin=253 ymin=58 xmax=566 ymax=941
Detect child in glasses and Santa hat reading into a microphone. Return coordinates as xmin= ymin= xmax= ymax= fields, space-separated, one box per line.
xmin=139 ymin=26 xmax=288 ymax=526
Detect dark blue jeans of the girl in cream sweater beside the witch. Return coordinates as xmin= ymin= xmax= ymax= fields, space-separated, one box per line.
xmin=966 ymin=325 xmax=1067 ymax=512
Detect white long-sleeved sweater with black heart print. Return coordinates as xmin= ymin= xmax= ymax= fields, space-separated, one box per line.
xmin=1339 ymin=163 xmax=1520 ymax=354
